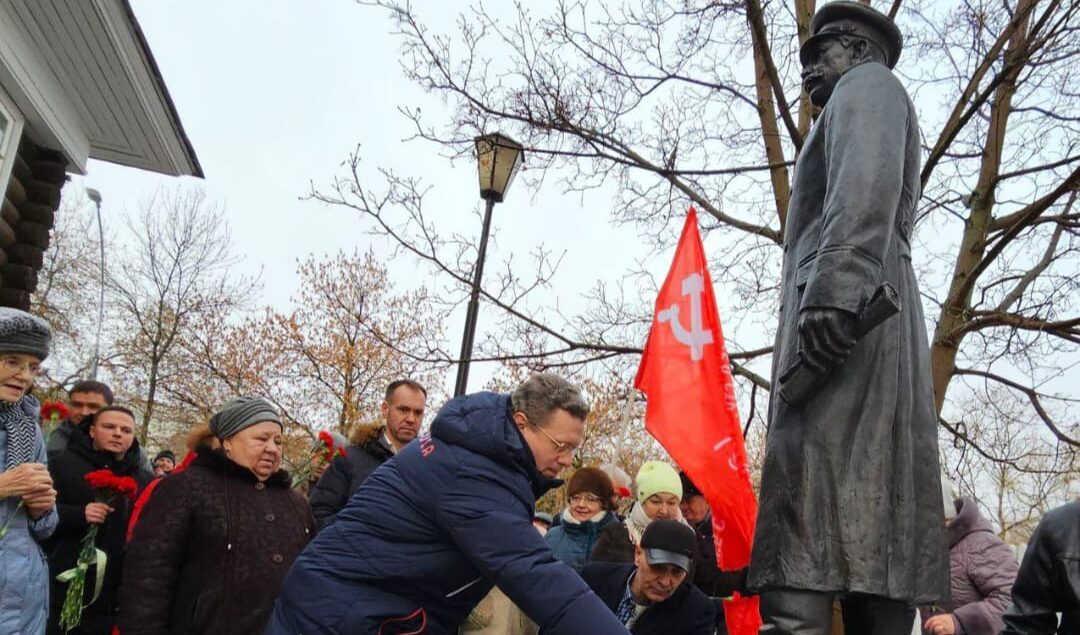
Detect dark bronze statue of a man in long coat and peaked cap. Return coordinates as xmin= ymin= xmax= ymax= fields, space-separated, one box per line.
xmin=748 ymin=1 xmax=948 ymax=635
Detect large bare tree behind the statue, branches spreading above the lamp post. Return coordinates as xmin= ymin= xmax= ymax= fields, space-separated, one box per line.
xmin=313 ymin=0 xmax=1080 ymax=455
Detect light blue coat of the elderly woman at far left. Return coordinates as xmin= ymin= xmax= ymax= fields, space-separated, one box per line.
xmin=0 ymin=396 xmax=63 ymax=635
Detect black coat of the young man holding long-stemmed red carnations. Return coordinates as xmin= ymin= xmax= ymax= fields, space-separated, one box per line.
xmin=43 ymin=425 xmax=153 ymax=635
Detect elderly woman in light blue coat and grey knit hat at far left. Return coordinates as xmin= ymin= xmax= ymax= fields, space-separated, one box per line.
xmin=0 ymin=308 xmax=57 ymax=635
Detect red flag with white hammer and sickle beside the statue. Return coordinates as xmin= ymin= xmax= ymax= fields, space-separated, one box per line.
xmin=634 ymin=207 xmax=761 ymax=635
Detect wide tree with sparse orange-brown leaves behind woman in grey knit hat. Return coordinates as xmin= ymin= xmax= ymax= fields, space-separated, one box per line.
xmin=168 ymin=253 xmax=442 ymax=462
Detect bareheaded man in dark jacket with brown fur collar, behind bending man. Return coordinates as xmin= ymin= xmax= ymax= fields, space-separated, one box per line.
xmin=309 ymin=379 xmax=428 ymax=529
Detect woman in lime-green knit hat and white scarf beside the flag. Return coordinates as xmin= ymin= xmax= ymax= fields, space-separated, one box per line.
xmin=593 ymin=461 xmax=686 ymax=563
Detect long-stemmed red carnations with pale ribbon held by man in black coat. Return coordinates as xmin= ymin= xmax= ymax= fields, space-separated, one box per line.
xmin=56 ymin=470 xmax=138 ymax=632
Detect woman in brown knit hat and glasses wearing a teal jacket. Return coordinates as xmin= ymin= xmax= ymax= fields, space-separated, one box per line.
xmin=546 ymin=468 xmax=617 ymax=573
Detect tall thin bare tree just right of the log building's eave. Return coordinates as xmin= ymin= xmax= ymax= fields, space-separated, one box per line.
xmin=108 ymin=188 xmax=255 ymax=443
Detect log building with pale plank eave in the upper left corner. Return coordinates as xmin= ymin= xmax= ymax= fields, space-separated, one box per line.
xmin=0 ymin=0 xmax=202 ymax=309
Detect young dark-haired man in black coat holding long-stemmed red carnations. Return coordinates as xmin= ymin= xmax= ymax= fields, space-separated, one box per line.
xmin=44 ymin=406 xmax=153 ymax=635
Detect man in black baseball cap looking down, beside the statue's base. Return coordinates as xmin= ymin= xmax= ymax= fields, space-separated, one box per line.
xmin=581 ymin=519 xmax=716 ymax=635
